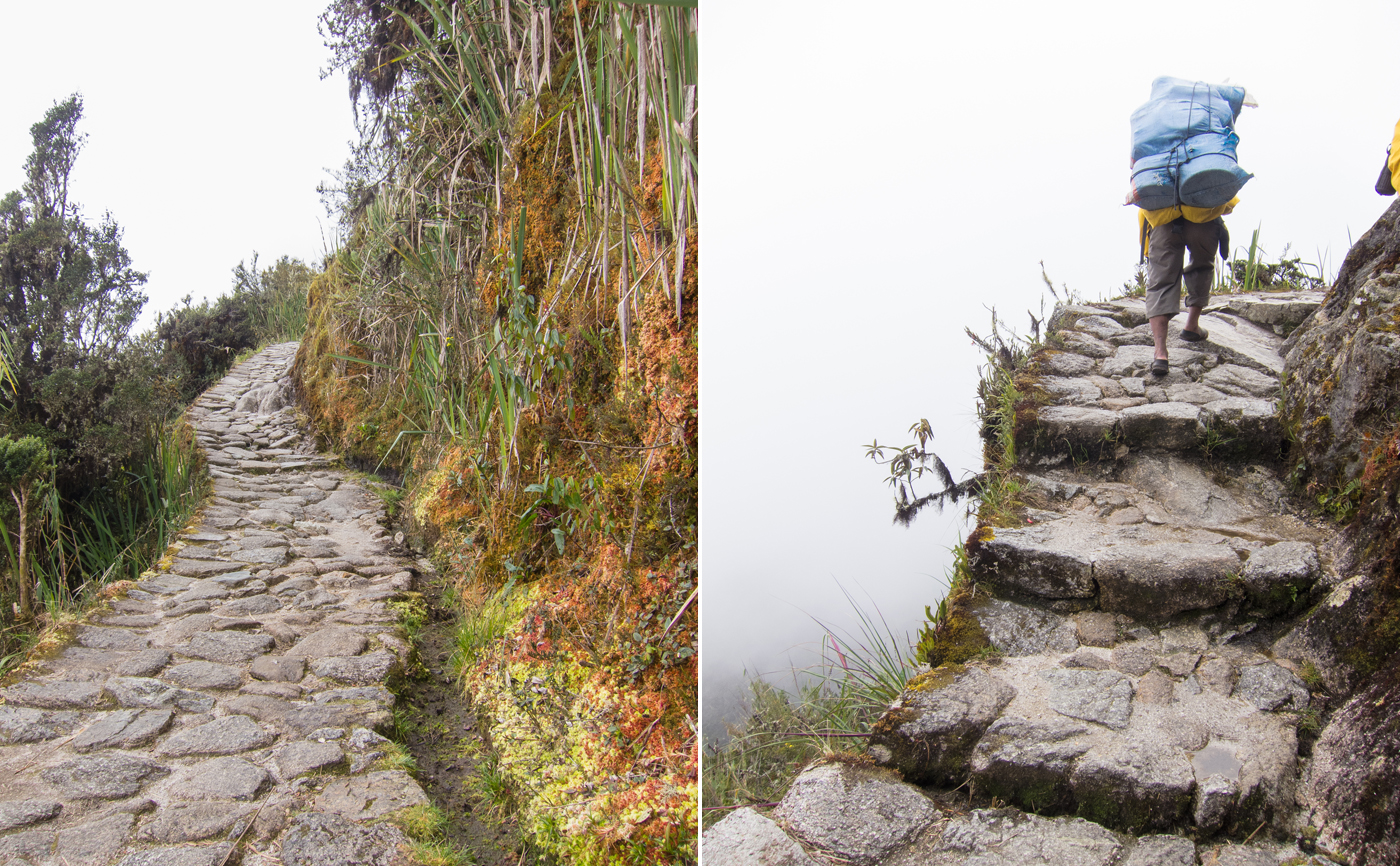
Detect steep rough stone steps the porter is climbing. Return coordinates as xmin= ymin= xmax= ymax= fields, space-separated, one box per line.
xmin=703 ymin=292 xmax=1345 ymax=866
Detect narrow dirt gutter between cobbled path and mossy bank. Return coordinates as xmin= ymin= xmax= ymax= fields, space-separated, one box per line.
xmin=399 ymin=578 xmax=529 ymax=866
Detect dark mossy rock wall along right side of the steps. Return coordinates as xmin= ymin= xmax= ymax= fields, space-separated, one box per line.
xmin=1285 ymin=201 xmax=1400 ymax=866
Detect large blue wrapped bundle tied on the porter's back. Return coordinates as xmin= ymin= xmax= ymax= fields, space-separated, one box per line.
xmin=1133 ymin=77 xmax=1253 ymax=210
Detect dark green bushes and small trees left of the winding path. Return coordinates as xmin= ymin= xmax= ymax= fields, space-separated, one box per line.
xmin=0 ymin=94 xmax=309 ymax=667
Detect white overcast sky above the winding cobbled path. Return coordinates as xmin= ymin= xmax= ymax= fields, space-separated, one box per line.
xmin=0 ymin=0 xmax=354 ymax=325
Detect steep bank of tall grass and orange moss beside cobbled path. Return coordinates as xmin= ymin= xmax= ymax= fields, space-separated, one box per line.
xmin=295 ymin=0 xmax=699 ymax=863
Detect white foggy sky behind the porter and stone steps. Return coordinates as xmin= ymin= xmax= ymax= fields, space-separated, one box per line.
xmin=700 ymin=0 xmax=1400 ymax=732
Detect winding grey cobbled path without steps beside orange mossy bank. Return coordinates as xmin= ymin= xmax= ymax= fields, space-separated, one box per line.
xmin=0 ymin=343 xmax=427 ymax=866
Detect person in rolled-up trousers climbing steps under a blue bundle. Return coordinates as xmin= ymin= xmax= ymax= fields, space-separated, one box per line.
xmin=1126 ymin=76 xmax=1257 ymax=376
